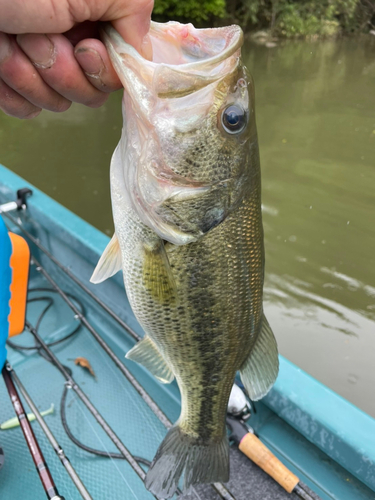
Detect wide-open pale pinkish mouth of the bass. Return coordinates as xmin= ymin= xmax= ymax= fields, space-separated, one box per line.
xmin=102 ymin=22 xmax=243 ymax=97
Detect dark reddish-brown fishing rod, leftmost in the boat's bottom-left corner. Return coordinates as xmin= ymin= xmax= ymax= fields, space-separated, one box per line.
xmin=1 ymin=362 xmax=64 ymax=500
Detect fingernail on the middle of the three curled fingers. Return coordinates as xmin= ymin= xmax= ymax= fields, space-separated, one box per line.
xmin=17 ymin=34 xmax=56 ymax=69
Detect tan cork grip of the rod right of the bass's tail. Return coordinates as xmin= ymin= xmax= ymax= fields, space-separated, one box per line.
xmin=238 ymin=432 xmax=299 ymax=493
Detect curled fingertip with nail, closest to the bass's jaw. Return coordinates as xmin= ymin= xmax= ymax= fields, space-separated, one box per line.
xmin=74 ymin=39 xmax=122 ymax=92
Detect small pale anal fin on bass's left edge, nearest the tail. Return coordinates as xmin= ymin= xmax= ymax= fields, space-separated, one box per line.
xmin=126 ymin=337 xmax=174 ymax=384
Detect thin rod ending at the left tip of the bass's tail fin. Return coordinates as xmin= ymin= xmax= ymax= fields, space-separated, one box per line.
xmin=25 ymin=321 xmax=162 ymax=498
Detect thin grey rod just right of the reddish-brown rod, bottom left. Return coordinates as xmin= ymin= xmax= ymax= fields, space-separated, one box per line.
xmin=7 ymin=363 xmax=93 ymax=500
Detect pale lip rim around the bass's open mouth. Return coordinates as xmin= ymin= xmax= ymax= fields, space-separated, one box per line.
xmin=100 ymin=21 xmax=244 ymax=72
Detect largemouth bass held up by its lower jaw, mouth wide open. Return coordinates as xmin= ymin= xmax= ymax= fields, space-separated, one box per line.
xmin=92 ymin=22 xmax=278 ymax=498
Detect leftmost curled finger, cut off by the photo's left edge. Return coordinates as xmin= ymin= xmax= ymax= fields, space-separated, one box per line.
xmin=0 ymin=33 xmax=70 ymax=111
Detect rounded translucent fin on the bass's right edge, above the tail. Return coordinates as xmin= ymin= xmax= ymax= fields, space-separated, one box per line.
xmin=240 ymin=314 xmax=279 ymax=401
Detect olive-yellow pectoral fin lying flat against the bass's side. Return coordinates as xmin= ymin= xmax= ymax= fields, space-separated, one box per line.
xmin=143 ymin=240 xmax=177 ymax=304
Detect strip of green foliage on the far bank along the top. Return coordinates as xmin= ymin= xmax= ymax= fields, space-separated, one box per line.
xmin=154 ymin=0 xmax=375 ymax=37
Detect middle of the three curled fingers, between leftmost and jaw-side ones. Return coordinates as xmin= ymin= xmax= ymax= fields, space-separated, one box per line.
xmin=17 ymin=34 xmax=108 ymax=108
